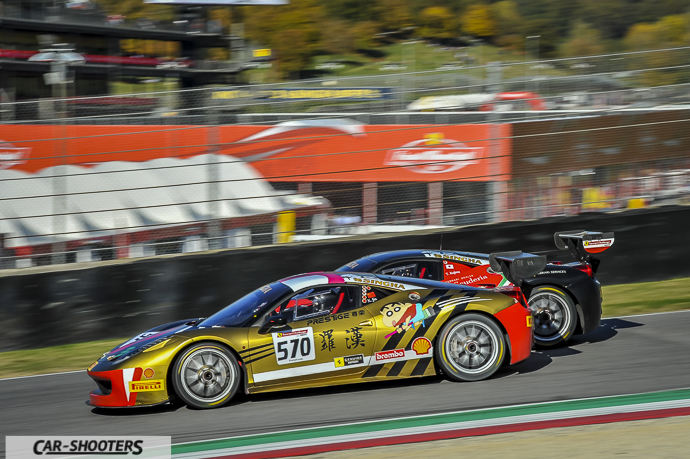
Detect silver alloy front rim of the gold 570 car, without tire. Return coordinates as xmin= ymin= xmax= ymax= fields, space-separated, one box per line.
xmin=180 ymin=348 xmax=237 ymax=403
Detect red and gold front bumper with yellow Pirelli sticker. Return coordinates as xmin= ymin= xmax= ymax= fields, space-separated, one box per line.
xmin=87 ymin=367 xmax=169 ymax=408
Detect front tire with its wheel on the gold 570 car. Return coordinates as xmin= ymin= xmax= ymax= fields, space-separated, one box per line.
xmin=172 ymin=342 xmax=242 ymax=409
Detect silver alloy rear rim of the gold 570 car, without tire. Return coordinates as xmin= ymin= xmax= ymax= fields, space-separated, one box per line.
xmin=445 ymin=320 xmax=500 ymax=374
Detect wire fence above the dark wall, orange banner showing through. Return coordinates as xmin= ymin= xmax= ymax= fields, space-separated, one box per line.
xmin=0 ymin=47 xmax=690 ymax=268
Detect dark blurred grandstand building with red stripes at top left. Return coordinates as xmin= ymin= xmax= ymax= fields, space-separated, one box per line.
xmin=0 ymin=0 xmax=241 ymax=112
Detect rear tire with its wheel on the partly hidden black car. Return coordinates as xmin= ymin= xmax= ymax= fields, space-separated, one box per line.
xmin=527 ymin=286 xmax=578 ymax=347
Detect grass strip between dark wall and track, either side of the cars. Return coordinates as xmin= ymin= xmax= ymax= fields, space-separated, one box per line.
xmin=0 ymin=278 xmax=690 ymax=378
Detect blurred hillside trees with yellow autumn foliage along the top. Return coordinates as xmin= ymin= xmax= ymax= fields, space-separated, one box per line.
xmin=95 ymin=0 xmax=690 ymax=79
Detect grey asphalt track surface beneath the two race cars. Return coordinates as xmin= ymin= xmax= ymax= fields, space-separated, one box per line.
xmin=0 ymin=311 xmax=690 ymax=457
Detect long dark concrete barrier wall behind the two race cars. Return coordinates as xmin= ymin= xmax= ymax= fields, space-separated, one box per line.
xmin=0 ymin=207 xmax=690 ymax=351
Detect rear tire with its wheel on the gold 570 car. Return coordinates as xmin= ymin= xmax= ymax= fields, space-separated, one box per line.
xmin=436 ymin=313 xmax=506 ymax=381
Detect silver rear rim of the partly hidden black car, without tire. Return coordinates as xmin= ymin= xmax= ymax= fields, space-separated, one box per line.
xmin=529 ymin=291 xmax=573 ymax=342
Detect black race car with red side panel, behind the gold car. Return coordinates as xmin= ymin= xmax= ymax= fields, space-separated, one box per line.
xmin=338 ymin=231 xmax=614 ymax=347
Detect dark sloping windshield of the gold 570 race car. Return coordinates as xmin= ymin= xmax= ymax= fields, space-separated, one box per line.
xmin=199 ymin=282 xmax=292 ymax=328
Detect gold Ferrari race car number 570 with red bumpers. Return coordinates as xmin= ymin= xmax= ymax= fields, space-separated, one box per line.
xmin=87 ymin=253 xmax=546 ymax=408
